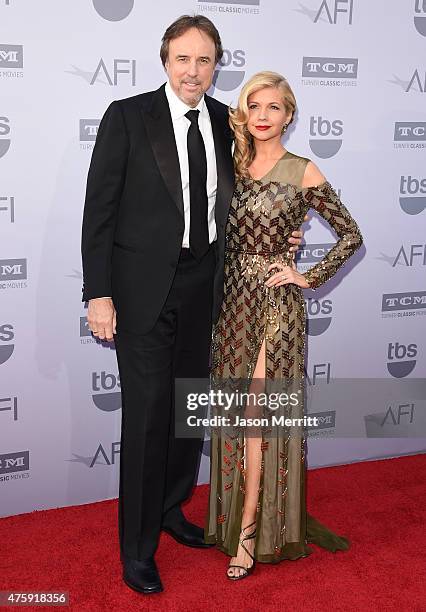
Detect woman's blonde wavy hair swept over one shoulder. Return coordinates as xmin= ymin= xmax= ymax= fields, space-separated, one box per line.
xmin=229 ymin=70 xmax=296 ymax=177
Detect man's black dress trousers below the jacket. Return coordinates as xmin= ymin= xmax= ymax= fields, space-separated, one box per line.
xmin=115 ymin=245 xmax=216 ymax=559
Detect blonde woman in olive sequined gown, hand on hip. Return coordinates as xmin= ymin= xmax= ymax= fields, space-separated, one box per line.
xmin=205 ymin=72 xmax=362 ymax=580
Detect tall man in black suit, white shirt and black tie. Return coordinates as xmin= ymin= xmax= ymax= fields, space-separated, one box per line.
xmin=82 ymin=15 xmax=301 ymax=593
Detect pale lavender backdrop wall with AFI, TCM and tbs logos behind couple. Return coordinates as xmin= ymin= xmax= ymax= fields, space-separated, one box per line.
xmin=0 ymin=0 xmax=426 ymax=515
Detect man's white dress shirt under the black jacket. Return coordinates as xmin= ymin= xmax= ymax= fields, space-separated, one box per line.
xmin=166 ymin=83 xmax=217 ymax=248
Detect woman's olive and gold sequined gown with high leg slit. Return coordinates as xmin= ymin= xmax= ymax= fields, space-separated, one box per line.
xmin=205 ymin=151 xmax=362 ymax=563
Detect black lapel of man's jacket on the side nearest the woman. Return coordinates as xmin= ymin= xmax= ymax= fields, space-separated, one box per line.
xmin=205 ymin=95 xmax=234 ymax=231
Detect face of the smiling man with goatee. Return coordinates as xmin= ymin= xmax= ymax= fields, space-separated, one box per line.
xmin=166 ymin=28 xmax=216 ymax=107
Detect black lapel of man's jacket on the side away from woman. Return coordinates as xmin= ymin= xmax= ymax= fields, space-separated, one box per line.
xmin=143 ymin=85 xmax=183 ymax=215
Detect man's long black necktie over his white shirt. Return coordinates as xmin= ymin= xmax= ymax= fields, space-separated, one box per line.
xmin=185 ymin=110 xmax=209 ymax=259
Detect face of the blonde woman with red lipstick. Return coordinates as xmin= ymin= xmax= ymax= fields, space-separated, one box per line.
xmin=247 ymin=87 xmax=291 ymax=140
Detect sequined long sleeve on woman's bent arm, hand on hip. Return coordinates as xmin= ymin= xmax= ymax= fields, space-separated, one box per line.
xmin=302 ymin=181 xmax=363 ymax=289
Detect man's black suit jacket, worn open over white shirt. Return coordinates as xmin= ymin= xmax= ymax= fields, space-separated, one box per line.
xmin=82 ymin=85 xmax=234 ymax=334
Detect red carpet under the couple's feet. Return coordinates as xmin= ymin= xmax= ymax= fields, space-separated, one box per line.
xmin=0 ymin=455 xmax=426 ymax=612
